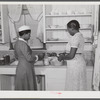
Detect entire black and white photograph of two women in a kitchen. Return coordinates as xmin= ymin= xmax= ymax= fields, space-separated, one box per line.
xmin=0 ymin=2 xmax=100 ymax=98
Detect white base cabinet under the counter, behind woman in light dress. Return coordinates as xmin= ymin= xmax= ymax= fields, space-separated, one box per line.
xmin=45 ymin=65 xmax=93 ymax=91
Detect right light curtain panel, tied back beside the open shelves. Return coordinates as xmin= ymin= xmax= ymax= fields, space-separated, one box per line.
xmin=27 ymin=5 xmax=43 ymax=43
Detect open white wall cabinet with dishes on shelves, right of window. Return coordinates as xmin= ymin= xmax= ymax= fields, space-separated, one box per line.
xmin=44 ymin=5 xmax=95 ymax=50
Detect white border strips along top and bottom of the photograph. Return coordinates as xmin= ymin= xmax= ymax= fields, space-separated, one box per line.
xmin=0 ymin=0 xmax=100 ymax=100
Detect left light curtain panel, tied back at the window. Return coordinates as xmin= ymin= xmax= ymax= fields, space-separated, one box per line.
xmin=8 ymin=5 xmax=22 ymax=42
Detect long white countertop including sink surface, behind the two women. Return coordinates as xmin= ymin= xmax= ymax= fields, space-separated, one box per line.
xmin=0 ymin=59 xmax=93 ymax=75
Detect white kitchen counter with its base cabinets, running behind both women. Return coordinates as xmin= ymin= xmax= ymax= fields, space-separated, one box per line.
xmin=0 ymin=65 xmax=93 ymax=91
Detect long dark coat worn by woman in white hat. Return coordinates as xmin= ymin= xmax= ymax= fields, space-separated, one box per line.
xmin=14 ymin=40 xmax=37 ymax=90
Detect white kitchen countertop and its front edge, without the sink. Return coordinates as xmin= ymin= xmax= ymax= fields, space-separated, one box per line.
xmin=0 ymin=65 xmax=93 ymax=75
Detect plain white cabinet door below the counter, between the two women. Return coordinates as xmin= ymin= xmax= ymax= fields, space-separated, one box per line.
xmin=46 ymin=68 xmax=66 ymax=91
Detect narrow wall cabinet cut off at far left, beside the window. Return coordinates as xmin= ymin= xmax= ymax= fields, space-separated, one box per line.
xmin=0 ymin=5 xmax=9 ymax=43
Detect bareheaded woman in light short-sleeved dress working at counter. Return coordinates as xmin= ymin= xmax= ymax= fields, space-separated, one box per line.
xmin=58 ymin=20 xmax=86 ymax=91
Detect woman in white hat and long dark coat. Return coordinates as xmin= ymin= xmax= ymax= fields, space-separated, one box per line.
xmin=14 ymin=25 xmax=43 ymax=90
